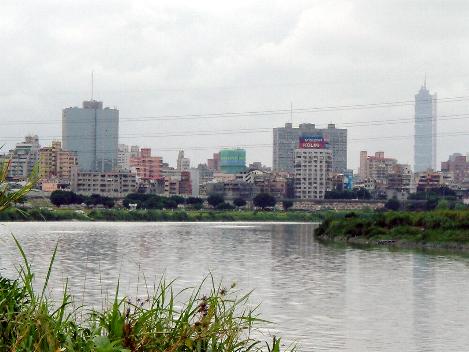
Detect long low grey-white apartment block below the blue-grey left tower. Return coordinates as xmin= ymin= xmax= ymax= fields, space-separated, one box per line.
xmin=70 ymin=167 xmax=137 ymax=198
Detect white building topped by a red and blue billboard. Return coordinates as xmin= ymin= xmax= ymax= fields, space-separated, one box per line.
xmin=294 ymin=137 xmax=333 ymax=199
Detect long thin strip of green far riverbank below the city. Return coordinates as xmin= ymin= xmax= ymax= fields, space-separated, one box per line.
xmin=0 ymin=208 xmax=325 ymax=222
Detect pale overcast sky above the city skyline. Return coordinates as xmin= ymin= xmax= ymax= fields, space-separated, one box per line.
xmin=0 ymin=0 xmax=469 ymax=168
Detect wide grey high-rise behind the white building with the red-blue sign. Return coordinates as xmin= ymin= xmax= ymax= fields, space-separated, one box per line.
xmin=273 ymin=123 xmax=347 ymax=173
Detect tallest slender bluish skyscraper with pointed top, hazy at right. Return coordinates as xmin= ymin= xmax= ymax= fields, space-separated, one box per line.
xmin=414 ymin=82 xmax=437 ymax=172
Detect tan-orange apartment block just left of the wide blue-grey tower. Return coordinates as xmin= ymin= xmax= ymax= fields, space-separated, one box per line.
xmin=39 ymin=141 xmax=78 ymax=182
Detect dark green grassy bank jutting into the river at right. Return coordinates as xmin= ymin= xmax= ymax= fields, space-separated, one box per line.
xmin=315 ymin=210 xmax=469 ymax=252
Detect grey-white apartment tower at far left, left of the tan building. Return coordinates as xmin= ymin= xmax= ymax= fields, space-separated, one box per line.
xmin=8 ymin=135 xmax=41 ymax=181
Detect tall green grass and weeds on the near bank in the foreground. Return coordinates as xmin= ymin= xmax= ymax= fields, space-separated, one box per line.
xmin=0 ymin=239 xmax=292 ymax=352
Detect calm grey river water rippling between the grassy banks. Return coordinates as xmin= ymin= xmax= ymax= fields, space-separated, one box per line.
xmin=0 ymin=222 xmax=469 ymax=351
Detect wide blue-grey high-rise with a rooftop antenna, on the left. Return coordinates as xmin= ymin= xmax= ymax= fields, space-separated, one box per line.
xmin=62 ymin=100 xmax=119 ymax=172
